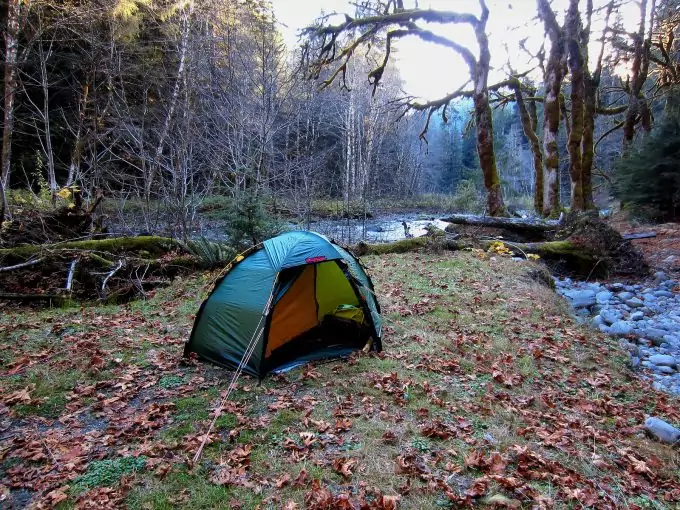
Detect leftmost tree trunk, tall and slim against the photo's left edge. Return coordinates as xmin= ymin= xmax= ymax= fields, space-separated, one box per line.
xmin=0 ymin=0 xmax=21 ymax=189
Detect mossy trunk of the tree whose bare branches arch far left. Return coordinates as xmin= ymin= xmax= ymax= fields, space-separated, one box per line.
xmin=473 ymin=0 xmax=506 ymax=216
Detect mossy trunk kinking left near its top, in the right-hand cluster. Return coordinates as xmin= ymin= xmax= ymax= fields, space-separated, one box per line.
xmin=538 ymin=0 xmax=564 ymax=216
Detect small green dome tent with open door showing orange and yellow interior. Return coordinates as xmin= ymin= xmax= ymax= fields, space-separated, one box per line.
xmin=184 ymin=231 xmax=382 ymax=378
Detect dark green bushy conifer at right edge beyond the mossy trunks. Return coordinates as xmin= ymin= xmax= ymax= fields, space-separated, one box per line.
xmin=614 ymin=117 xmax=680 ymax=221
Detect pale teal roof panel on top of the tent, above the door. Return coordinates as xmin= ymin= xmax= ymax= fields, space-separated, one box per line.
xmin=264 ymin=230 xmax=342 ymax=270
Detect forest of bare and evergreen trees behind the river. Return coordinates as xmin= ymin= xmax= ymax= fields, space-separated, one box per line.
xmin=0 ymin=0 xmax=680 ymax=238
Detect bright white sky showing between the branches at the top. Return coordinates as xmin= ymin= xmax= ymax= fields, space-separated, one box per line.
xmin=273 ymin=0 xmax=639 ymax=99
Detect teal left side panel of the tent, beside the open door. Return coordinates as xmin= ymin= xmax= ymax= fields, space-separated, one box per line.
xmin=191 ymin=250 xmax=277 ymax=376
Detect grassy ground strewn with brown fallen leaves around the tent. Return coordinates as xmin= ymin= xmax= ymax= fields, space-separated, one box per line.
xmin=0 ymin=252 xmax=680 ymax=509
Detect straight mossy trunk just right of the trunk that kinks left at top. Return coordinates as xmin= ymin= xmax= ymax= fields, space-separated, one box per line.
xmin=565 ymin=0 xmax=586 ymax=211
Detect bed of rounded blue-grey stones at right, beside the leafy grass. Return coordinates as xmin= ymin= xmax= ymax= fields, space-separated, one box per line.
xmin=555 ymin=272 xmax=680 ymax=395
